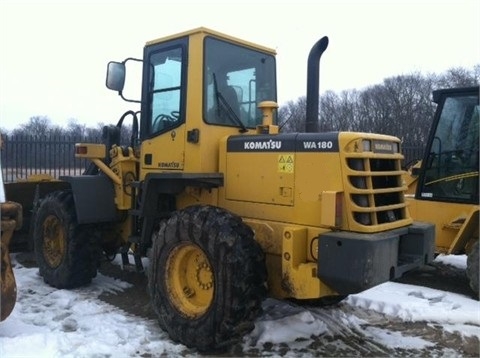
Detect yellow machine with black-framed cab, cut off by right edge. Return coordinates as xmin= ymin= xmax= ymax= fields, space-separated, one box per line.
xmin=405 ymin=86 xmax=480 ymax=297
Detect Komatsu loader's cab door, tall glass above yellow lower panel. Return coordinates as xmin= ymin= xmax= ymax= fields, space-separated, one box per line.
xmin=140 ymin=37 xmax=188 ymax=178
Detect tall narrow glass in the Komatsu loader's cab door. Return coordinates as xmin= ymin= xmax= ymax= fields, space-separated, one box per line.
xmin=149 ymin=47 xmax=182 ymax=133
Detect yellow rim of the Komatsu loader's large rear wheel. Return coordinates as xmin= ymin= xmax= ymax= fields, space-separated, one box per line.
xmin=165 ymin=244 xmax=215 ymax=318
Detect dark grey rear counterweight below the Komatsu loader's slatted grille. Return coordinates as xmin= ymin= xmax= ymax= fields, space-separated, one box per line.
xmin=317 ymin=222 xmax=435 ymax=295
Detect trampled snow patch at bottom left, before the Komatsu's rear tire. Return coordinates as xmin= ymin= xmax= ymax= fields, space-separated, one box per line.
xmin=0 ymin=264 xmax=182 ymax=357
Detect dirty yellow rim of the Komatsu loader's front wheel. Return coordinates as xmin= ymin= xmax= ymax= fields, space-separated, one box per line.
xmin=42 ymin=215 xmax=66 ymax=268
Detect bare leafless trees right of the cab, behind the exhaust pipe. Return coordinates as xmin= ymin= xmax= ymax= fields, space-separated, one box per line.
xmin=278 ymin=64 xmax=480 ymax=148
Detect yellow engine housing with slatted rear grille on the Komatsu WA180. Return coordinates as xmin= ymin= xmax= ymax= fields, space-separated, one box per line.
xmin=210 ymin=133 xmax=412 ymax=299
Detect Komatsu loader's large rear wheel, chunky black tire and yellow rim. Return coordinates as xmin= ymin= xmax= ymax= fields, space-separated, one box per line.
xmin=148 ymin=206 xmax=267 ymax=352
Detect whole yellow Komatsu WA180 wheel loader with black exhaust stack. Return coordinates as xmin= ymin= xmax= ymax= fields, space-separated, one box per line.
xmin=7 ymin=28 xmax=435 ymax=351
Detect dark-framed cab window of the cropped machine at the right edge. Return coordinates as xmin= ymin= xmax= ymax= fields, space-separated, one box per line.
xmin=421 ymin=96 xmax=480 ymax=202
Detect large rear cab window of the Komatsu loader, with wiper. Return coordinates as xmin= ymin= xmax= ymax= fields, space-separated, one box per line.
xmin=203 ymin=37 xmax=276 ymax=128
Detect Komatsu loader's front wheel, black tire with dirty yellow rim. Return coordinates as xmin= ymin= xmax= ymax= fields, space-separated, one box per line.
xmin=33 ymin=191 xmax=100 ymax=288
